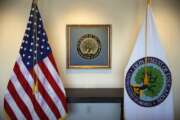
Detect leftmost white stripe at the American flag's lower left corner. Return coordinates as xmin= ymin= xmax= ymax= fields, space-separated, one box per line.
xmin=5 ymin=90 xmax=26 ymax=120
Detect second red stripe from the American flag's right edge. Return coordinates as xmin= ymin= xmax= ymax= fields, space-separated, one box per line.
xmin=38 ymin=62 xmax=67 ymax=112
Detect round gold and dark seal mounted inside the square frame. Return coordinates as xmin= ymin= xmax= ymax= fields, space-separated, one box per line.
xmin=77 ymin=34 xmax=101 ymax=60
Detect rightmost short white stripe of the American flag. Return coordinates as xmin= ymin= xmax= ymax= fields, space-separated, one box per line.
xmin=43 ymin=57 xmax=65 ymax=95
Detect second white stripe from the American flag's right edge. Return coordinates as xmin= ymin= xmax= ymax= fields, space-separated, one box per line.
xmin=34 ymin=65 xmax=66 ymax=116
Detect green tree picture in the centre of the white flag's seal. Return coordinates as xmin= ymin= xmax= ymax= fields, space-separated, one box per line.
xmin=131 ymin=66 xmax=164 ymax=97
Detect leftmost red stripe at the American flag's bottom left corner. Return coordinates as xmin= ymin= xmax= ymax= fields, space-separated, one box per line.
xmin=4 ymin=99 xmax=17 ymax=120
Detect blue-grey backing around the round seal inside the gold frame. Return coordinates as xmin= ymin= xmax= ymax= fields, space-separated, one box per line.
xmin=70 ymin=27 xmax=109 ymax=65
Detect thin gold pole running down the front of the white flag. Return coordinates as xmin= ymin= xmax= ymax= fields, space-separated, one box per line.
xmin=144 ymin=0 xmax=151 ymax=86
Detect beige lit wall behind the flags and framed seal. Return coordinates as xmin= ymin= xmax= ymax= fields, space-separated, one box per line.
xmin=0 ymin=0 xmax=180 ymax=119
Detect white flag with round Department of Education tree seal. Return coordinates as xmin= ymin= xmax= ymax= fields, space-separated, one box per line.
xmin=124 ymin=6 xmax=174 ymax=120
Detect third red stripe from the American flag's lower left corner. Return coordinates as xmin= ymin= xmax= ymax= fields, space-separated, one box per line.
xmin=14 ymin=63 xmax=49 ymax=120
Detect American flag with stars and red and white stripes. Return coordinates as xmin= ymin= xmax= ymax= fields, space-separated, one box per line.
xmin=4 ymin=3 xmax=67 ymax=120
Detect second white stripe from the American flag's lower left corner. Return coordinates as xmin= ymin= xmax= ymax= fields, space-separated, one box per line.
xmin=11 ymin=72 xmax=39 ymax=120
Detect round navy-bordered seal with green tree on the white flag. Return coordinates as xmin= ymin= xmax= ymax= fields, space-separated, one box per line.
xmin=125 ymin=57 xmax=172 ymax=107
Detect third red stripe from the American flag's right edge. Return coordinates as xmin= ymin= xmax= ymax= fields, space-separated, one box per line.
xmin=30 ymin=70 xmax=61 ymax=119
